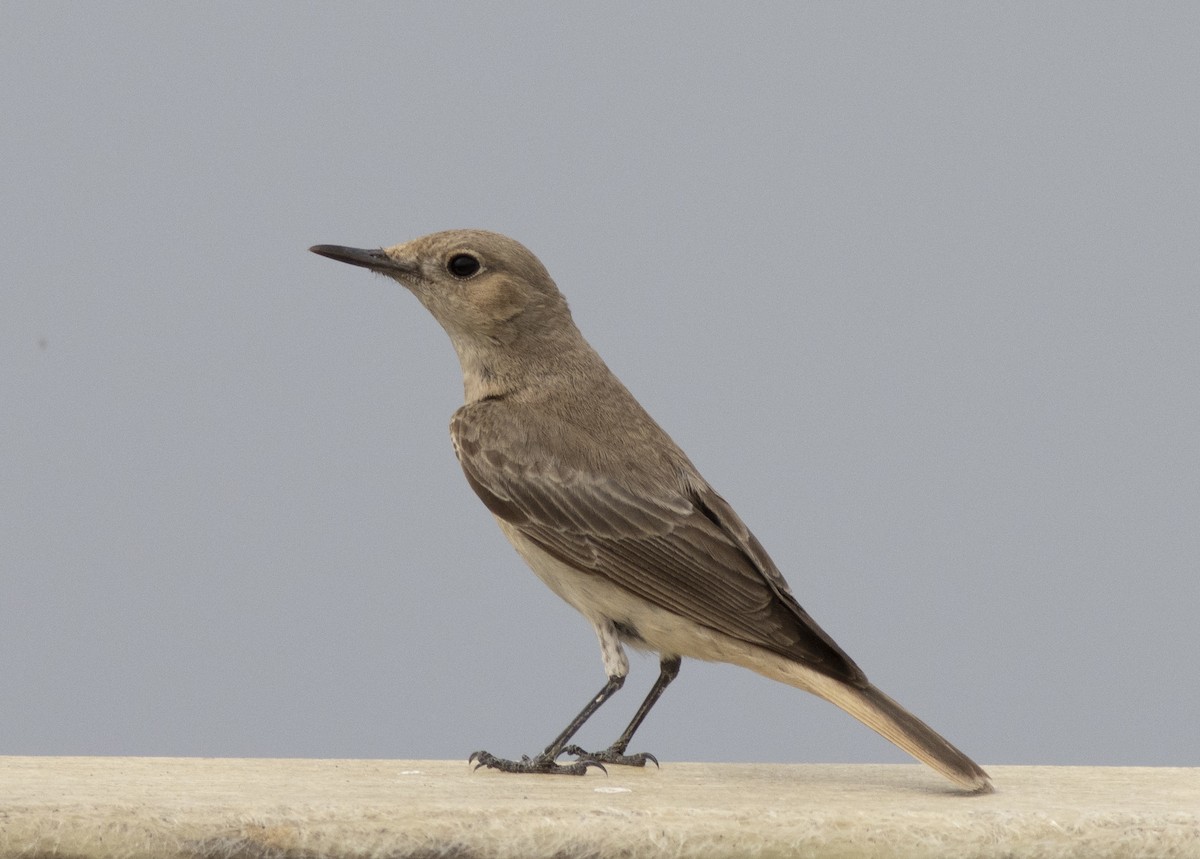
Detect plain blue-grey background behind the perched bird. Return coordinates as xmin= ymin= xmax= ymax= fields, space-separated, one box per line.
xmin=0 ymin=2 xmax=1200 ymax=765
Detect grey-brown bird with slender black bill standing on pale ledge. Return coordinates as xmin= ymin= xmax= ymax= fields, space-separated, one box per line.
xmin=310 ymin=229 xmax=992 ymax=793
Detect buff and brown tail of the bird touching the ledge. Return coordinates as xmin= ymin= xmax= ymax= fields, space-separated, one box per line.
xmin=812 ymin=683 xmax=992 ymax=793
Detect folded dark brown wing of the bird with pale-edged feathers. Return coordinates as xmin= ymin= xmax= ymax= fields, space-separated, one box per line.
xmin=451 ymin=409 xmax=865 ymax=685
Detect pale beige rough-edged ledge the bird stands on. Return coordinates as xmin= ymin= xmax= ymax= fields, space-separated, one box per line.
xmin=0 ymin=757 xmax=1200 ymax=859
